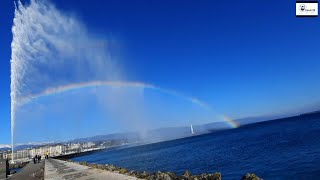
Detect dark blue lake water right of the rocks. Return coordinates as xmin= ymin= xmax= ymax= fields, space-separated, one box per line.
xmin=73 ymin=114 xmax=320 ymax=179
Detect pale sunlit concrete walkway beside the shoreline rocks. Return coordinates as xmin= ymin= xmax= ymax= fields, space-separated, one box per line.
xmin=44 ymin=158 xmax=137 ymax=180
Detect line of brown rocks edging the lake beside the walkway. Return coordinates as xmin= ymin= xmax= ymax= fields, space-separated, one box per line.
xmin=64 ymin=159 xmax=262 ymax=180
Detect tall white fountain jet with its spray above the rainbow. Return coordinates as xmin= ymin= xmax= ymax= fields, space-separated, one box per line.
xmin=11 ymin=0 xmax=120 ymax=158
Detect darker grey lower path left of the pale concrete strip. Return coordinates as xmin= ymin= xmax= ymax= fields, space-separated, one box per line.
xmin=8 ymin=160 xmax=44 ymax=180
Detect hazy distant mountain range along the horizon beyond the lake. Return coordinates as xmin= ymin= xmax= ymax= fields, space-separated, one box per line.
xmin=0 ymin=110 xmax=320 ymax=151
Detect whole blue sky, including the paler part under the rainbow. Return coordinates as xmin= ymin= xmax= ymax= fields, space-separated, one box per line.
xmin=0 ymin=0 xmax=320 ymax=144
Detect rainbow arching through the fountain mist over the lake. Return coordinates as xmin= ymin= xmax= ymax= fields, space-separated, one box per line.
xmin=18 ymin=81 xmax=240 ymax=128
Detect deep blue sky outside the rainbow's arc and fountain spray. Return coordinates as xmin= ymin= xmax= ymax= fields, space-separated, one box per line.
xmin=0 ymin=0 xmax=320 ymax=143
